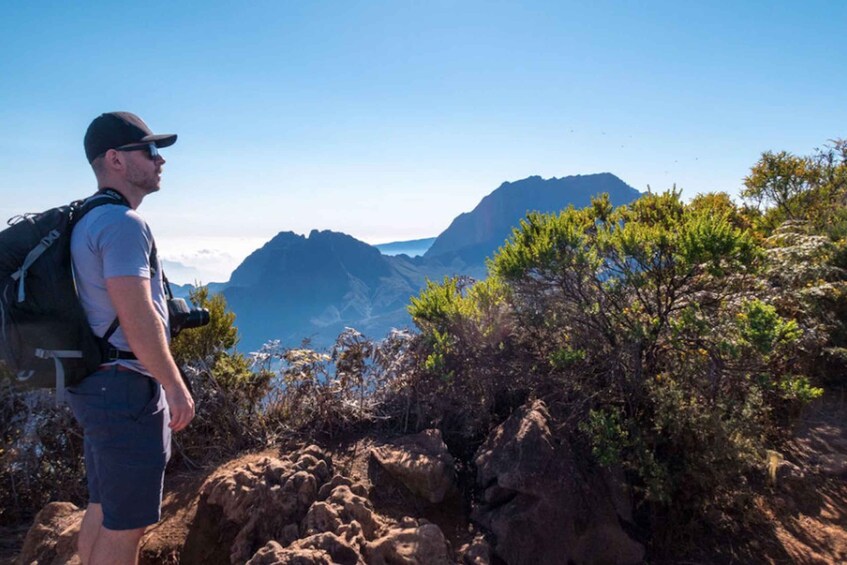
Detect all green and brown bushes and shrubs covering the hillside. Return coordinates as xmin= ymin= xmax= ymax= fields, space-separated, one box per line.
xmin=0 ymin=141 xmax=847 ymax=556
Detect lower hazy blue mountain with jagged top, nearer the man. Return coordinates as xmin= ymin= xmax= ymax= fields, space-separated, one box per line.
xmin=224 ymin=231 xmax=423 ymax=349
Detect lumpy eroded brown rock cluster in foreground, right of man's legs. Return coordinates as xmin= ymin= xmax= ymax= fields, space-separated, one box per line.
xmin=184 ymin=447 xmax=453 ymax=565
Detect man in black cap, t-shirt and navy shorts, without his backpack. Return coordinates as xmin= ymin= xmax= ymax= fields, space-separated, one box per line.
xmin=68 ymin=112 xmax=194 ymax=565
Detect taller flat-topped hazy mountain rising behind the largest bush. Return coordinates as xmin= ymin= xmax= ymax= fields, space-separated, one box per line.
xmin=425 ymin=173 xmax=640 ymax=264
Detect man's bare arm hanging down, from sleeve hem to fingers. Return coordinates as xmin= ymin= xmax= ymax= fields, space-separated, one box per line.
xmin=106 ymin=277 xmax=194 ymax=432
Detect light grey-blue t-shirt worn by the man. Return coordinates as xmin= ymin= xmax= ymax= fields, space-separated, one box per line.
xmin=71 ymin=198 xmax=170 ymax=375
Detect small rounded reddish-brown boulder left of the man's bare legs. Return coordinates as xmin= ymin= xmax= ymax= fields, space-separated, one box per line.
xmin=18 ymin=502 xmax=84 ymax=565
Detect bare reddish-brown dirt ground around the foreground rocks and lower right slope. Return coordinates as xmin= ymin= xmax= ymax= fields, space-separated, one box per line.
xmin=0 ymin=393 xmax=847 ymax=565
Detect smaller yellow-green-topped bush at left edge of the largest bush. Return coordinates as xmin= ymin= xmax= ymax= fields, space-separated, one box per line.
xmin=408 ymin=277 xmax=537 ymax=442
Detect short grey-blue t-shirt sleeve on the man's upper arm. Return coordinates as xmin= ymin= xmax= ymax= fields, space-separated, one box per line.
xmin=95 ymin=209 xmax=153 ymax=279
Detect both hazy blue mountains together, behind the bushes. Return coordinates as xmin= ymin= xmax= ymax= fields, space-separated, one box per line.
xmin=223 ymin=173 xmax=639 ymax=351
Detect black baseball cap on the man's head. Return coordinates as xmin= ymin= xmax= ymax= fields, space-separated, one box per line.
xmin=85 ymin=112 xmax=176 ymax=163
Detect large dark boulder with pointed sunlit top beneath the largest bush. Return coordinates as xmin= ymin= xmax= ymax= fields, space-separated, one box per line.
xmin=474 ymin=401 xmax=644 ymax=565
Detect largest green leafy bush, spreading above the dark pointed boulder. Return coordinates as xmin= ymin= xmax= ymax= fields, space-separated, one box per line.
xmin=410 ymin=186 xmax=839 ymax=528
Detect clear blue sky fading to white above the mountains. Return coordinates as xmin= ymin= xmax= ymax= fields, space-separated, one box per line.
xmin=0 ymin=0 xmax=847 ymax=280
